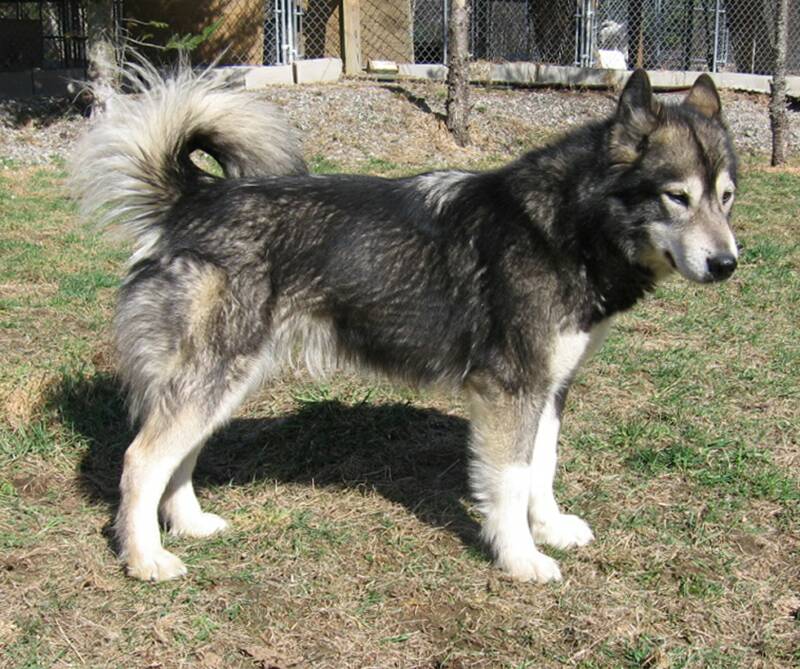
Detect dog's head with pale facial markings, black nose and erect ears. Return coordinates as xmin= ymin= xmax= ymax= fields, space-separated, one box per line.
xmin=609 ymin=70 xmax=738 ymax=283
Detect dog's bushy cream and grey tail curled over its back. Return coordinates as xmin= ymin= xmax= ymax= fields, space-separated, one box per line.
xmin=71 ymin=61 xmax=307 ymax=244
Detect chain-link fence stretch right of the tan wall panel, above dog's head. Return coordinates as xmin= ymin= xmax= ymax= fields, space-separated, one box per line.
xmin=406 ymin=0 xmax=800 ymax=74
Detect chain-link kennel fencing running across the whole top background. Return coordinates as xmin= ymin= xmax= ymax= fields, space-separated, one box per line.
xmin=0 ymin=0 xmax=800 ymax=74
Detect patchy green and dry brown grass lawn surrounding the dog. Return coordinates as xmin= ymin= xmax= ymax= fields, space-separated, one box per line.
xmin=0 ymin=157 xmax=800 ymax=669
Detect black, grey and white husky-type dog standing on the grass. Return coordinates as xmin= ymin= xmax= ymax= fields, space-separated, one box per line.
xmin=72 ymin=63 xmax=737 ymax=583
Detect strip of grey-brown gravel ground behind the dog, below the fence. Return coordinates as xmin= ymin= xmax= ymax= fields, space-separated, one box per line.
xmin=0 ymin=81 xmax=800 ymax=171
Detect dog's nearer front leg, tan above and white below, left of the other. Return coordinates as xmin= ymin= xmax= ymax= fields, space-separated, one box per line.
xmin=462 ymin=387 xmax=561 ymax=583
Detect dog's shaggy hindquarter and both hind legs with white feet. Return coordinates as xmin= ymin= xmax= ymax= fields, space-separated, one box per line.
xmin=116 ymin=255 xmax=272 ymax=580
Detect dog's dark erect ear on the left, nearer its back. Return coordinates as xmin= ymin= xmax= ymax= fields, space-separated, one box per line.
xmin=611 ymin=70 xmax=659 ymax=163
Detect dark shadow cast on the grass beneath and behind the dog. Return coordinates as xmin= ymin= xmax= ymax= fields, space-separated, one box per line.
xmin=50 ymin=373 xmax=479 ymax=547
